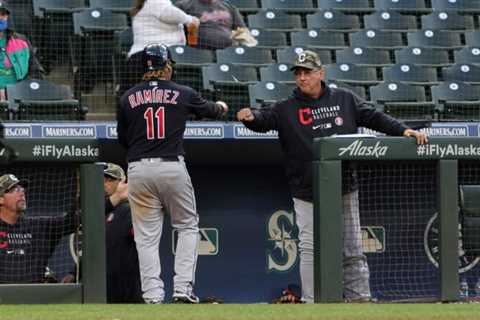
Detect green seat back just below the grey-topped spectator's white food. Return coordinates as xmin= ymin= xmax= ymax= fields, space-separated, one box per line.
xmin=216 ymin=46 xmax=274 ymax=66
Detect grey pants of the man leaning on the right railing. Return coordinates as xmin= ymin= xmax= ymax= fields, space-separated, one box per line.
xmin=293 ymin=191 xmax=370 ymax=303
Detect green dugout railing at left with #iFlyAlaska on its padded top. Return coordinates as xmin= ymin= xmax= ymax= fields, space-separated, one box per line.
xmin=0 ymin=139 xmax=106 ymax=304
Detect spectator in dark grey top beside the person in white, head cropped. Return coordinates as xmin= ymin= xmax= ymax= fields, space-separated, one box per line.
xmin=175 ymin=0 xmax=256 ymax=49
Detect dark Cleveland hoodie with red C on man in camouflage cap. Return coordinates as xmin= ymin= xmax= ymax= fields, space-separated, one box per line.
xmin=244 ymin=82 xmax=408 ymax=201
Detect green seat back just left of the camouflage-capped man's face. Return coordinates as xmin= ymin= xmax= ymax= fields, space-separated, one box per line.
xmin=248 ymin=81 xmax=292 ymax=107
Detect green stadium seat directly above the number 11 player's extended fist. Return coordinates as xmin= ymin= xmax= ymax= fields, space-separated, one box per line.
xmin=202 ymin=63 xmax=258 ymax=119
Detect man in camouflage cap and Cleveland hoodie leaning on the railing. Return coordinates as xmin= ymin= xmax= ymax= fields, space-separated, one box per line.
xmin=237 ymin=50 xmax=427 ymax=302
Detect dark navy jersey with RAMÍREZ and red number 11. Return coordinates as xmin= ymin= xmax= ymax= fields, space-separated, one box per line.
xmin=117 ymin=80 xmax=223 ymax=162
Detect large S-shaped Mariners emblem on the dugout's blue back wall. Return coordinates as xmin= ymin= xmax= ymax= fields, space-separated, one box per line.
xmin=267 ymin=210 xmax=298 ymax=272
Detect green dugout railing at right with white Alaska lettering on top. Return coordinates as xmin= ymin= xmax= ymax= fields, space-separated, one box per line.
xmin=313 ymin=135 xmax=480 ymax=302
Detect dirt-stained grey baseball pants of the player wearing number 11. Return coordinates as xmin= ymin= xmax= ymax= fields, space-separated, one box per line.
xmin=128 ymin=158 xmax=199 ymax=301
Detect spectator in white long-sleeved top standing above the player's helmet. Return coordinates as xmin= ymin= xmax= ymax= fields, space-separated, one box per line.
xmin=122 ymin=0 xmax=200 ymax=96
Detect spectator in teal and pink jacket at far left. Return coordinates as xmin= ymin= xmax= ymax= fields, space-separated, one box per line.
xmin=0 ymin=1 xmax=44 ymax=96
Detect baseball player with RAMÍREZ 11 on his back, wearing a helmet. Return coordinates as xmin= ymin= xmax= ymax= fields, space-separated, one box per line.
xmin=117 ymin=44 xmax=228 ymax=303
